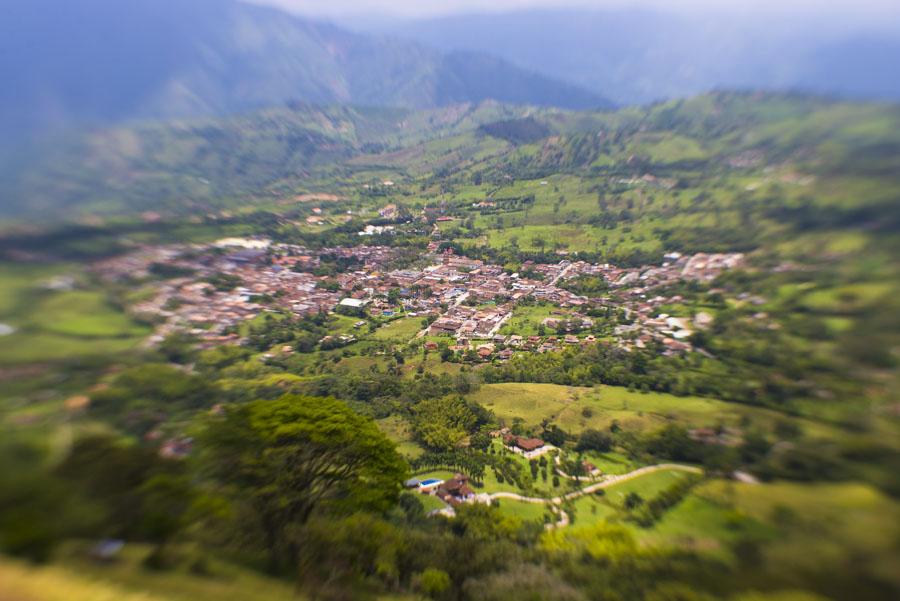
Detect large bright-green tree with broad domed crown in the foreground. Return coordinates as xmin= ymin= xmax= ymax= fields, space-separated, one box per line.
xmin=203 ymin=395 xmax=406 ymax=569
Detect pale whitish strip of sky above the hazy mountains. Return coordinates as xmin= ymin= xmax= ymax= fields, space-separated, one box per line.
xmin=251 ymin=0 xmax=900 ymax=20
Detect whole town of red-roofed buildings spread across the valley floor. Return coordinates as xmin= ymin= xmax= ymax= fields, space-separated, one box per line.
xmin=95 ymin=233 xmax=743 ymax=360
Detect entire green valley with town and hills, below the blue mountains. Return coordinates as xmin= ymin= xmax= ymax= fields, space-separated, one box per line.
xmin=0 ymin=92 xmax=900 ymax=601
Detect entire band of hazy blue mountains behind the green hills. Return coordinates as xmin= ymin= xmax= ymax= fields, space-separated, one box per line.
xmin=0 ymin=0 xmax=900 ymax=145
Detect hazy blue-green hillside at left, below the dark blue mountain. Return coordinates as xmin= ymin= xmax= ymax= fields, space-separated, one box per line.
xmin=0 ymin=102 xmax=564 ymax=220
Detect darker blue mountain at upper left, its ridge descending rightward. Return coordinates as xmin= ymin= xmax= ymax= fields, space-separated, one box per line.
xmin=0 ymin=0 xmax=610 ymax=141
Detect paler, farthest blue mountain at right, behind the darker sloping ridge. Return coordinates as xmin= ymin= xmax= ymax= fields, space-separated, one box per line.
xmin=374 ymin=8 xmax=900 ymax=104
